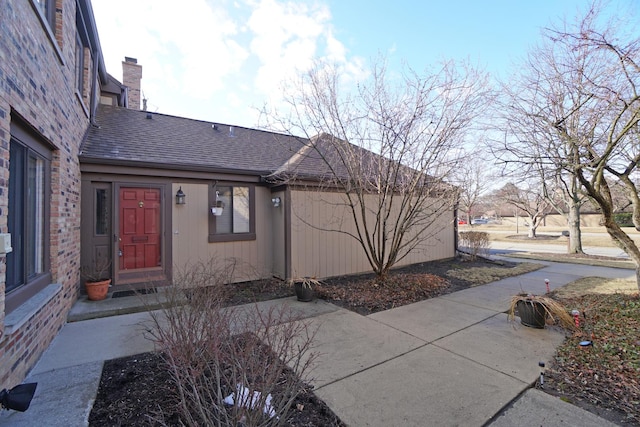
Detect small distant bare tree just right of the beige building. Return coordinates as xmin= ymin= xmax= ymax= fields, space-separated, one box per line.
xmin=494 ymin=182 xmax=550 ymax=239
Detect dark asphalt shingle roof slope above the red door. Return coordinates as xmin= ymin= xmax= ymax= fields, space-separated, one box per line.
xmin=80 ymin=105 xmax=308 ymax=175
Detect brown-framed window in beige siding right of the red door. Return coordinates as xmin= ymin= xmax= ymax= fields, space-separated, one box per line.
xmin=209 ymin=185 xmax=256 ymax=242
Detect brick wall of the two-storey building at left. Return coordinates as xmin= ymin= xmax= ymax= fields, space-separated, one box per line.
xmin=0 ymin=0 xmax=91 ymax=388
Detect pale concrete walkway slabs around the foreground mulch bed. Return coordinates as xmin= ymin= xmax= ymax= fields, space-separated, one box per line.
xmin=0 ymin=263 xmax=634 ymax=427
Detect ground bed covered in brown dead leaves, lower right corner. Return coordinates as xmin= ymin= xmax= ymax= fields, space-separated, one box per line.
xmin=547 ymin=294 xmax=640 ymax=424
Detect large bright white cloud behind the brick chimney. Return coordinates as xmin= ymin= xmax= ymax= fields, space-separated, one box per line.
xmin=92 ymin=0 xmax=362 ymax=126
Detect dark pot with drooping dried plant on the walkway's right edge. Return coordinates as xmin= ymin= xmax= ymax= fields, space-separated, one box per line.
xmin=508 ymin=292 xmax=575 ymax=329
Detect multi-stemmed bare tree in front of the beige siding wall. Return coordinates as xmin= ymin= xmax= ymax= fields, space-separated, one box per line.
xmin=264 ymin=62 xmax=488 ymax=277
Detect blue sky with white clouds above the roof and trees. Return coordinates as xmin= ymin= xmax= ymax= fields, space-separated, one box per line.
xmin=92 ymin=0 xmax=640 ymax=127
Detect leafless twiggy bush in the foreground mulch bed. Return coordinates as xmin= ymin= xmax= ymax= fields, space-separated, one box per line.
xmin=144 ymin=260 xmax=315 ymax=426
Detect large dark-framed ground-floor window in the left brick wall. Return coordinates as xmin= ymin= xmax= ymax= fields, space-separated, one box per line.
xmin=5 ymin=120 xmax=51 ymax=312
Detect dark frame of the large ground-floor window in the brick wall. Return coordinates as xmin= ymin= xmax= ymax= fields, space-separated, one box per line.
xmin=4 ymin=117 xmax=53 ymax=314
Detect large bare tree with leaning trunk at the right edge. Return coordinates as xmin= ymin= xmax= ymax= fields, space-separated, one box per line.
xmin=500 ymin=4 xmax=640 ymax=287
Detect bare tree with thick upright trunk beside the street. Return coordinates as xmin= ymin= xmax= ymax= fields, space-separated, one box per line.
xmin=495 ymin=18 xmax=589 ymax=253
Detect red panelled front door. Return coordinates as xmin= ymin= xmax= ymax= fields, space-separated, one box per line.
xmin=119 ymin=187 xmax=162 ymax=273
